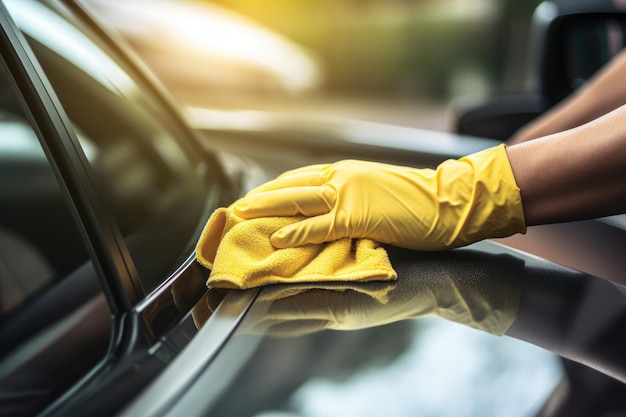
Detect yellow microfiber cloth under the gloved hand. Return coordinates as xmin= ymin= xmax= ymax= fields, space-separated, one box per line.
xmin=196 ymin=208 xmax=397 ymax=289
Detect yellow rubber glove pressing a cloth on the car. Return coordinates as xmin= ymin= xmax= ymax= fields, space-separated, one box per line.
xmin=233 ymin=145 xmax=526 ymax=251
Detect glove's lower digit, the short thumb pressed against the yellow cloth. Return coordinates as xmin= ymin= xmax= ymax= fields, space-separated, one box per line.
xmin=270 ymin=213 xmax=347 ymax=248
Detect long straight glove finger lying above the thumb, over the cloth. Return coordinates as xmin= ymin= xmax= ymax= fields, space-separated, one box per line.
xmin=233 ymin=187 xmax=336 ymax=219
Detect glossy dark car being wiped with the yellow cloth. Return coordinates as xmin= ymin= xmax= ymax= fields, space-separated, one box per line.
xmin=0 ymin=0 xmax=626 ymax=417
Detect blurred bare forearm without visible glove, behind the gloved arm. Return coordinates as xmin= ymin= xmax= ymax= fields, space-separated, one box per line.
xmin=508 ymin=50 xmax=626 ymax=145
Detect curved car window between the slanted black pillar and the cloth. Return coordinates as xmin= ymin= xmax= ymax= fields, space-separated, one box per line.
xmin=8 ymin=1 xmax=206 ymax=292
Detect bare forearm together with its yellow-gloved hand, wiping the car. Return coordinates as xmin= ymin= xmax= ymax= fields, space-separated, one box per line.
xmin=234 ymin=107 xmax=626 ymax=250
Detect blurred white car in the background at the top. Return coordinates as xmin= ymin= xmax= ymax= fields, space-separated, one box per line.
xmin=87 ymin=0 xmax=323 ymax=102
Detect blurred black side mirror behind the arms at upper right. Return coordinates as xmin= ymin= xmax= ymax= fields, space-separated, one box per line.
xmin=452 ymin=0 xmax=626 ymax=141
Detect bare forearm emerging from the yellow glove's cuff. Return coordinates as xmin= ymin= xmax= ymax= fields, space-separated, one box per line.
xmin=507 ymin=106 xmax=626 ymax=226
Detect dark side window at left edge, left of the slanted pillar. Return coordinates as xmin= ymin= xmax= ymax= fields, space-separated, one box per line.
xmin=0 ymin=51 xmax=111 ymax=415
